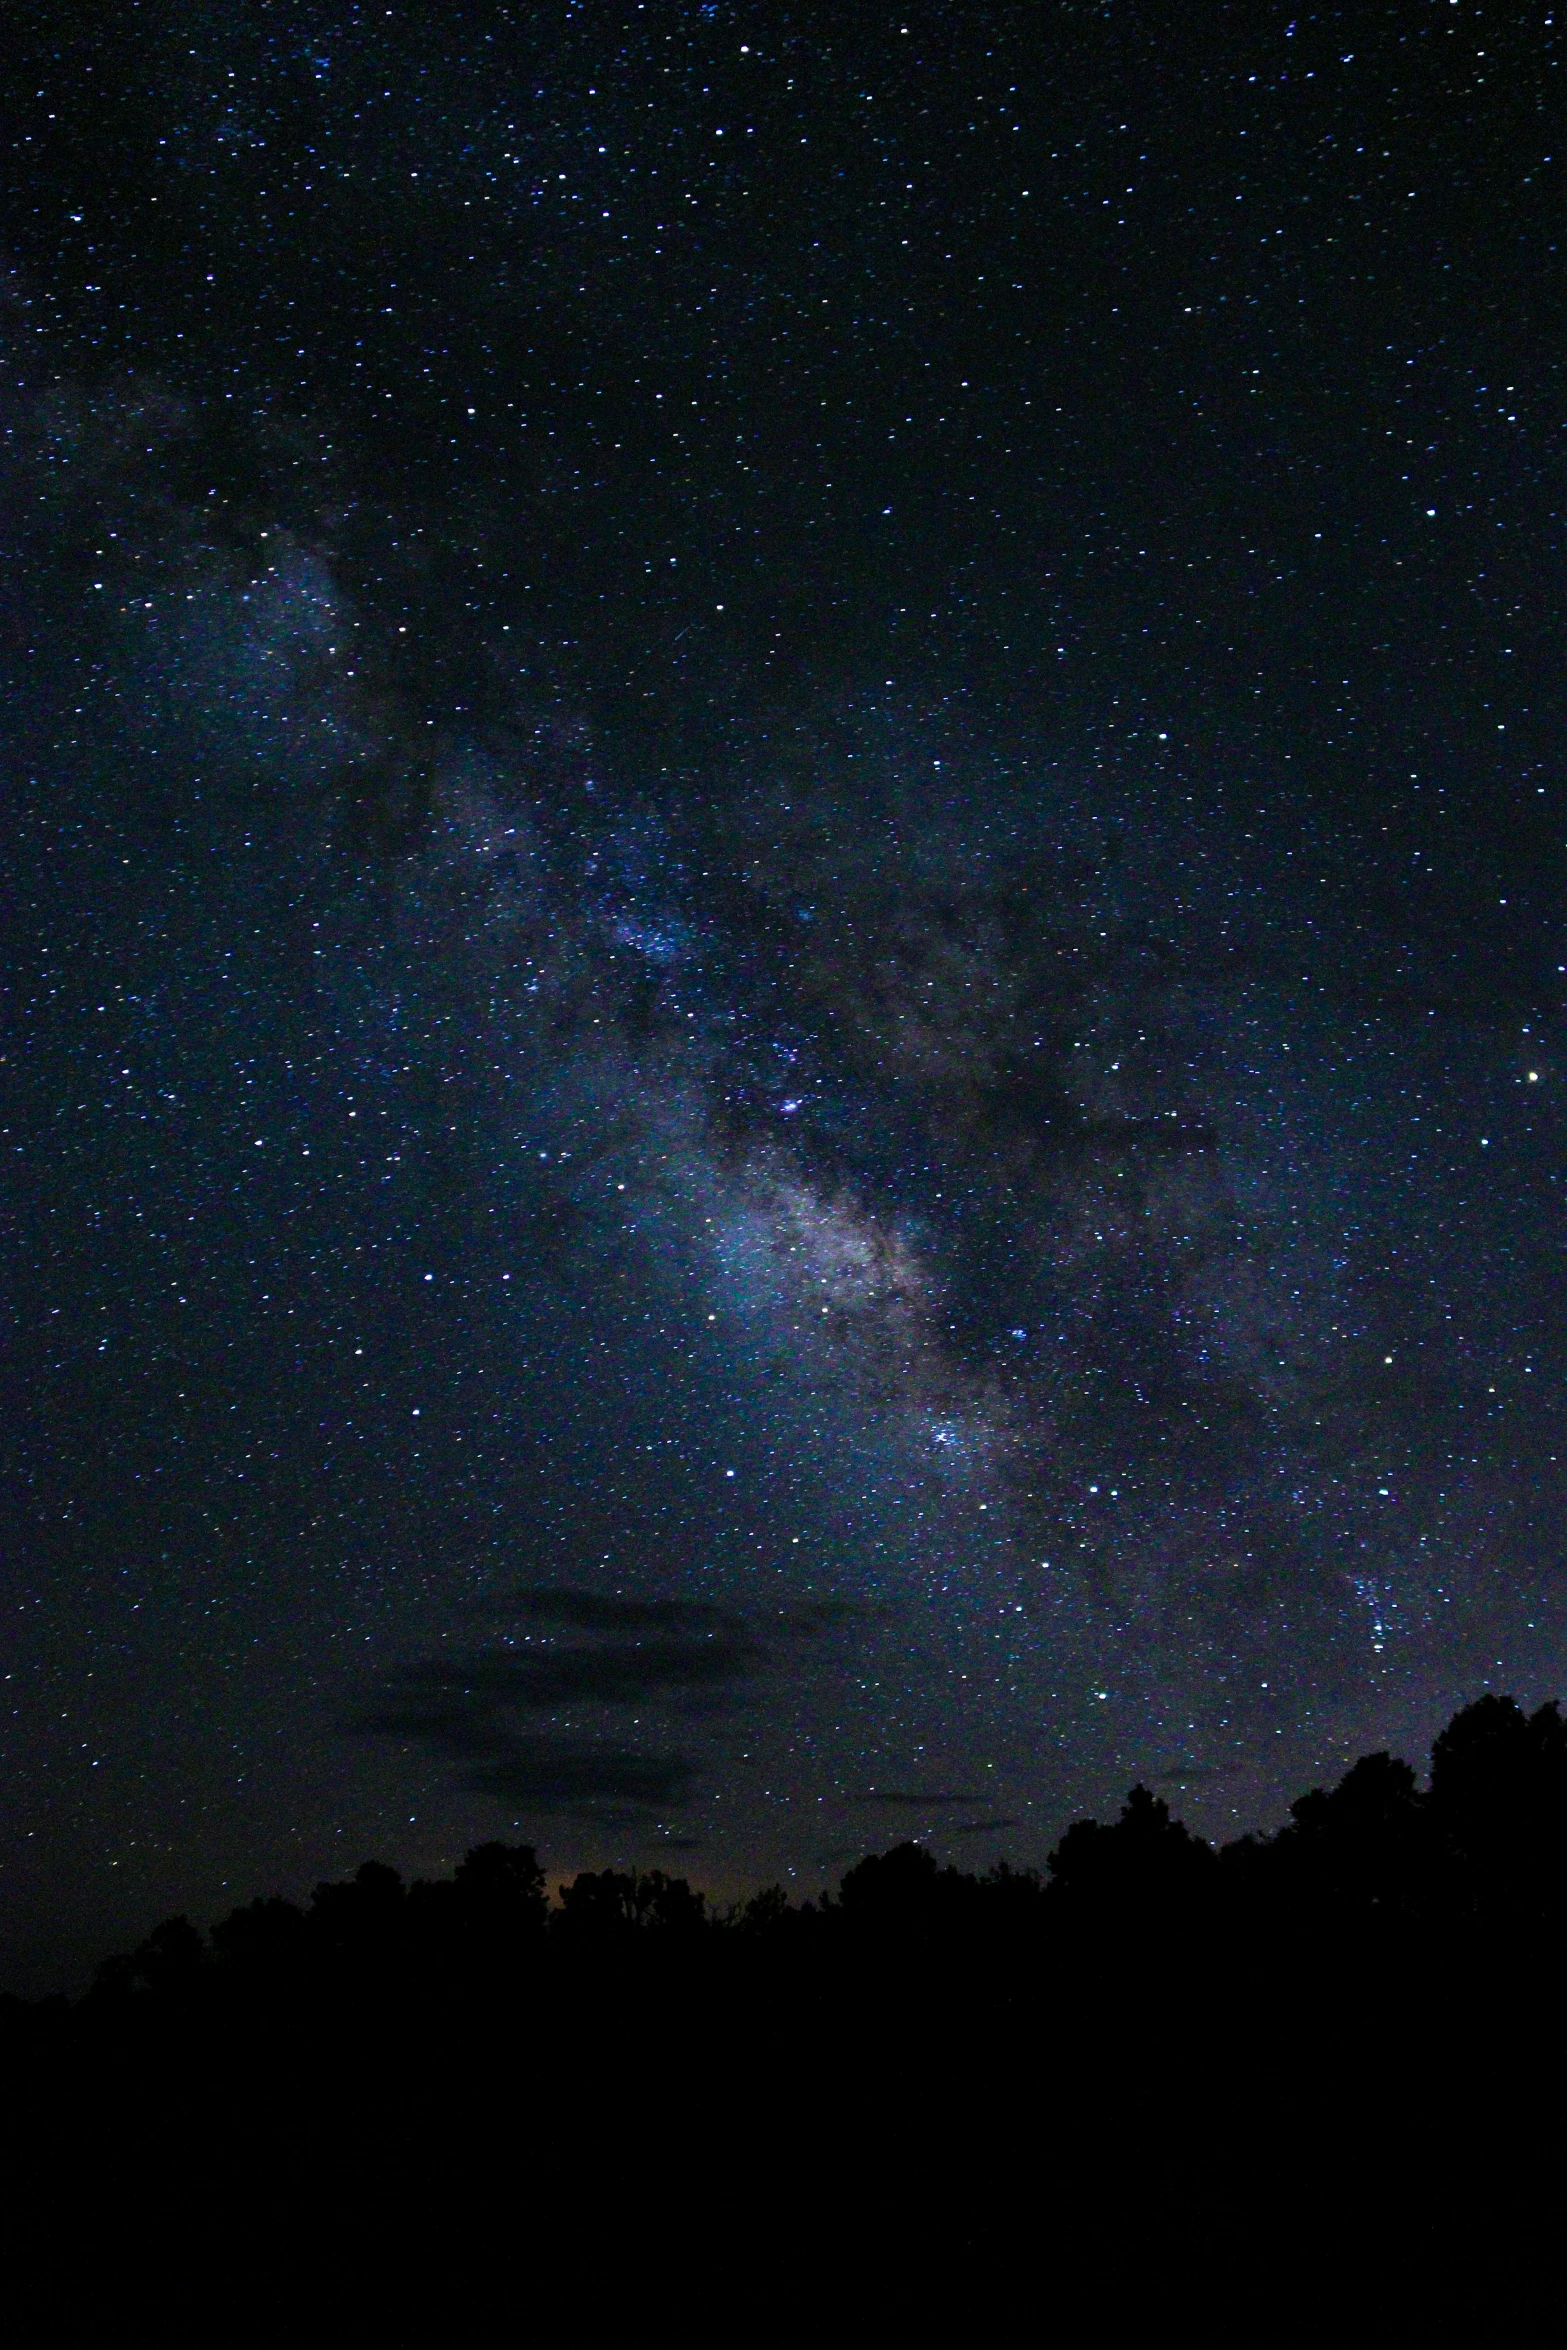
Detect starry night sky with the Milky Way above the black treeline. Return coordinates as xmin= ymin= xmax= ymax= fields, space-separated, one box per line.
xmin=0 ymin=0 xmax=1567 ymax=1988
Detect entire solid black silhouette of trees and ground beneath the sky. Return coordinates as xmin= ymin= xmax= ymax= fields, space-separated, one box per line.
xmin=0 ymin=1697 xmax=1567 ymax=2341
